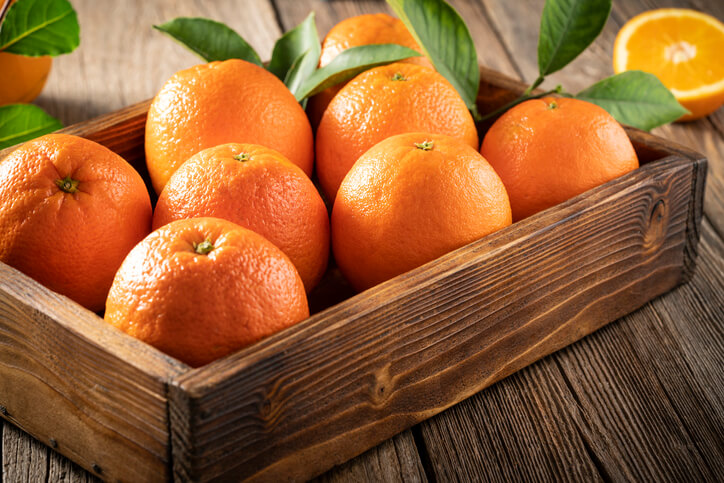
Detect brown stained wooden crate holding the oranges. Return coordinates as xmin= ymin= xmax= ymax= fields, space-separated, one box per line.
xmin=0 ymin=69 xmax=706 ymax=482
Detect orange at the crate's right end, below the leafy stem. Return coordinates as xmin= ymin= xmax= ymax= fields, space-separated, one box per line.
xmin=480 ymin=98 xmax=639 ymax=221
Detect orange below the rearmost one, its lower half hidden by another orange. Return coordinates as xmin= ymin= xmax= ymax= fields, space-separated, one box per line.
xmin=316 ymin=63 xmax=478 ymax=200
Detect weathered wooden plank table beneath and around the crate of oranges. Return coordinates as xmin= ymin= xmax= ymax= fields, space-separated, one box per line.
xmin=0 ymin=0 xmax=724 ymax=482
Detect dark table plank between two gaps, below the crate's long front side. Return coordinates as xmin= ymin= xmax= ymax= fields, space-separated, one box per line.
xmin=412 ymin=358 xmax=603 ymax=482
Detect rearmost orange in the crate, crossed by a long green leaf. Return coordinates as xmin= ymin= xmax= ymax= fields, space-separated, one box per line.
xmin=307 ymin=13 xmax=432 ymax=127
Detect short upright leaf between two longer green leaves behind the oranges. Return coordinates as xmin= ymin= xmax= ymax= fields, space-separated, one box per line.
xmin=268 ymin=12 xmax=322 ymax=82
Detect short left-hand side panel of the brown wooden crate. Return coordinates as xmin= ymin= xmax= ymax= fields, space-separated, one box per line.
xmin=0 ymin=263 xmax=185 ymax=481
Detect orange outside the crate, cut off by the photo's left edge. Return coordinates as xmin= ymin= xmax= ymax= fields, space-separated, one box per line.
xmin=0 ymin=52 xmax=53 ymax=106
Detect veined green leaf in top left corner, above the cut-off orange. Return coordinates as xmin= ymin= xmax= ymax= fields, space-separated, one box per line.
xmin=0 ymin=0 xmax=80 ymax=57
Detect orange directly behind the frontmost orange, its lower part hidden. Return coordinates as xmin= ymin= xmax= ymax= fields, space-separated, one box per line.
xmin=153 ymin=144 xmax=329 ymax=291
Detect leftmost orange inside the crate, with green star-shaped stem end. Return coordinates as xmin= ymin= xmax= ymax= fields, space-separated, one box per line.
xmin=0 ymin=134 xmax=151 ymax=311
